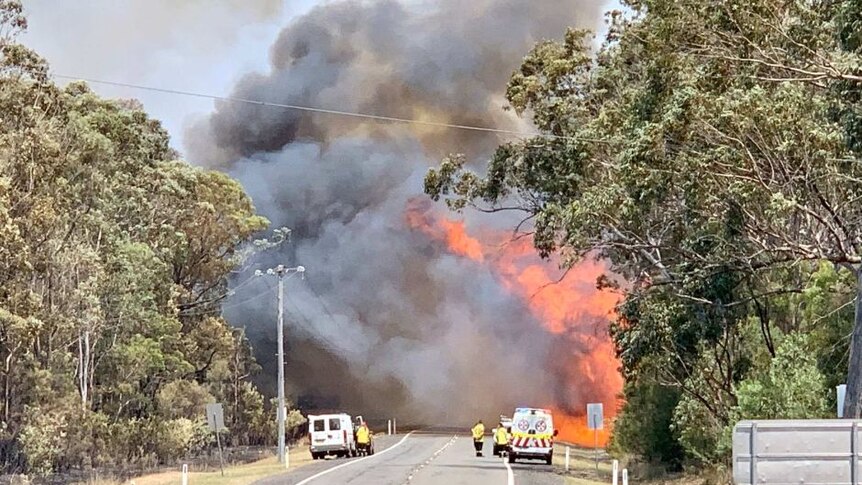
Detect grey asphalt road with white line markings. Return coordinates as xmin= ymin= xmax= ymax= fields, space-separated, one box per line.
xmin=255 ymin=434 xmax=564 ymax=485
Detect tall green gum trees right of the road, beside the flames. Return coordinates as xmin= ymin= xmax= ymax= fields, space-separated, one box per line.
xmin=425 ymin=0 xmax=862 ymax=464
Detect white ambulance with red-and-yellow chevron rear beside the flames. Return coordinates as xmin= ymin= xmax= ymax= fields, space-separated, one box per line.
xmin=509 ymin=408 xmax=558 ymax=465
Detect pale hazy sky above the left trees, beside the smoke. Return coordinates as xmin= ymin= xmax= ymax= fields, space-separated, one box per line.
xmin=23 ymin=0 xmax=618 ymax=153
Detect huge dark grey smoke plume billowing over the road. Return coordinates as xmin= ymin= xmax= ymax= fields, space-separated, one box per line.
xmin=193 ymin=0 xmax=612 ymax=422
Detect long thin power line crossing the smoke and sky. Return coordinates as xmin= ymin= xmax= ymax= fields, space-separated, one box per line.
xmin=51 ymin=74 xmax=604 ymax=143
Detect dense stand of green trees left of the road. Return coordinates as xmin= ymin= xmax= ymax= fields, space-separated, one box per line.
xmin=0 ymin=1 xmax=294 ymax=473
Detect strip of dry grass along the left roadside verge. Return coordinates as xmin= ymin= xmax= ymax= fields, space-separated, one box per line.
xmin=71 ymin=447 xmax=312 ymax=485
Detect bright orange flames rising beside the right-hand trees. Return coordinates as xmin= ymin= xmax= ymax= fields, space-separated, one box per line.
xmin=405 ymin=199 xmax=623 ymax=447
